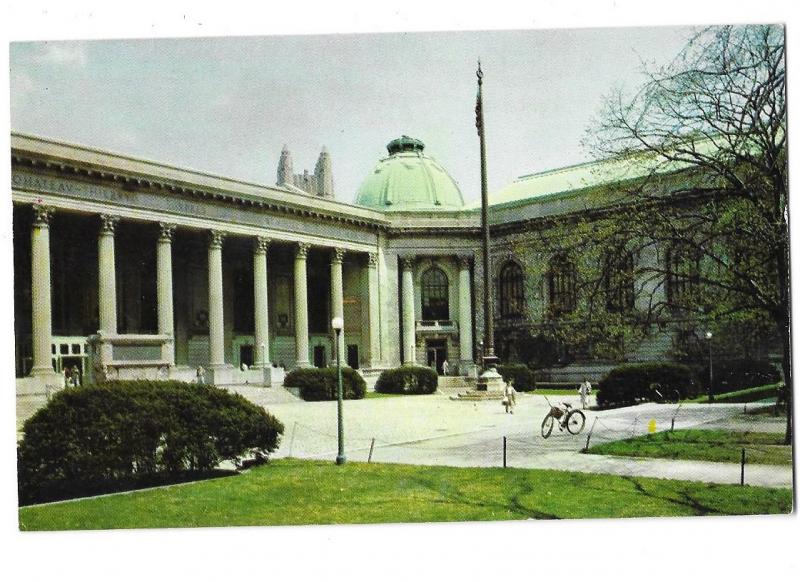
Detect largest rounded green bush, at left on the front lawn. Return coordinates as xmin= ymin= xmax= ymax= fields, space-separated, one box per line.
xmin=17 ymin=380 xmax=283 ymax=504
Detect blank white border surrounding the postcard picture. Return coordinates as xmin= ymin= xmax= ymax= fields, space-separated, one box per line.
xmin=0 ymin=0 xmax=800 ymax=582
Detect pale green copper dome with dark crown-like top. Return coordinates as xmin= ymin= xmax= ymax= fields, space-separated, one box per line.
xmin=356 ymin=135 xmax=464 ymax=212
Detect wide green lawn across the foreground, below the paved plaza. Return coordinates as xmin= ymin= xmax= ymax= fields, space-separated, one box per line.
xmin=19 ymin=459 xmax=792 ymax=530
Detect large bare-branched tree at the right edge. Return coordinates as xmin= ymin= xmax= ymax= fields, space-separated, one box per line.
xmin=587 ymin=25 xmax=792 ymax=443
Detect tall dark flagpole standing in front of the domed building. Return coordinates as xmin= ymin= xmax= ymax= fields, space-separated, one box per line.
xmin=475 ymin=60 xmax=498 ymax=371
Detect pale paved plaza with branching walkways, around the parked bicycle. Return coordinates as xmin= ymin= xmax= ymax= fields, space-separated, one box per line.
xmin=231 ymin=387 xmax=792 ymax=487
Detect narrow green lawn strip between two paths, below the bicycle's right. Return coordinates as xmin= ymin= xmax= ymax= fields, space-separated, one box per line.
xmin=589 ymin=430 xmax=792 ymax=465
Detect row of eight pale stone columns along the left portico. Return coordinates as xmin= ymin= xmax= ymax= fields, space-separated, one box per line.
xmin=31 ymin=204 xmax=384 ymax=376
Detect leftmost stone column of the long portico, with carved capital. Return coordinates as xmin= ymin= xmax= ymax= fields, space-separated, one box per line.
xmin=31 ymin=204 xmax=55 ymax=376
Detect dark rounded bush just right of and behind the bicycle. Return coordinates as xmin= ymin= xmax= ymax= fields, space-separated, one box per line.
xmin=597 ymin=363 xmax=697 ymax=407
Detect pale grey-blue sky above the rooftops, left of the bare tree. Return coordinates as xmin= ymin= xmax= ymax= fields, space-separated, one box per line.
xmin=9 ymin=27 xmax=693 ymax=202
